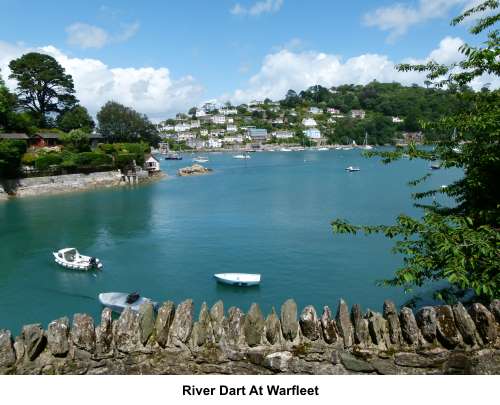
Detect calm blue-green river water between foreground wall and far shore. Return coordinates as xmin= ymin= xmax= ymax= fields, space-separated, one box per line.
xmin=0 ymin=150 xmax=456 ymax=332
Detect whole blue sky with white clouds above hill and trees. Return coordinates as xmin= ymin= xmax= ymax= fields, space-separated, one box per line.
xmin=0 ymin=0 xmax=499 ymax=121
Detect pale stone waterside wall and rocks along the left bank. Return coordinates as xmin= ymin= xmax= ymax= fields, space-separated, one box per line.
xmin=0 ymin=170 xmax=166 ymax=201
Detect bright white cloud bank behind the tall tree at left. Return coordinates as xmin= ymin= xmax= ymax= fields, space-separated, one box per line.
xmin=0 ymin=41 xmax=204 ymax=120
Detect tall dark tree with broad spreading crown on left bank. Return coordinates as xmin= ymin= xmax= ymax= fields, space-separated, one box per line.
xmin=9 ymin=52 xmax=77 ymax=127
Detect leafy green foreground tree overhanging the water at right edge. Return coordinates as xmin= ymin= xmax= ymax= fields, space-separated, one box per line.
xmin=332 ymin=0 xmax=500 ymax=301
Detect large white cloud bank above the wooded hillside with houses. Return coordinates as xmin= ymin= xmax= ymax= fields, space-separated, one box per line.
xmin=225 ymin=37 xmax=500 ymax=103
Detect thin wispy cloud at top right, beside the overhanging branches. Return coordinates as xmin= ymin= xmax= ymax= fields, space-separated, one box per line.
xmin=363 ymin=0 xmax=468 ymax=41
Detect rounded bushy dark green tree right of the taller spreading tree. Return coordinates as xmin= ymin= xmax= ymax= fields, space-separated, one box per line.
xmin=97 ymin=101 xmax=160 ymax=146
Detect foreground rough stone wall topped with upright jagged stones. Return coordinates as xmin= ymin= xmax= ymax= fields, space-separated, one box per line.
xmin=0 ymin=300 xmax=500 ymax=374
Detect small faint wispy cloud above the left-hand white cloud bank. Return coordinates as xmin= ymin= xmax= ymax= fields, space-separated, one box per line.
xmin=66 ymin=22 xmax=140 ymax=49
